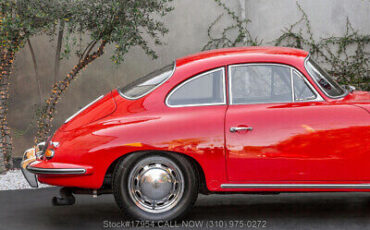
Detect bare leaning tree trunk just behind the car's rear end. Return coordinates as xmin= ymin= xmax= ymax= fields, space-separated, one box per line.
xmin=35 ymin=41 xmax=106 ymax=143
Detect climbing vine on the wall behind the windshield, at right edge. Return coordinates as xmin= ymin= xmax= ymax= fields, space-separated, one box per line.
xmin=275 ymin=3 xmax=370 ymax=90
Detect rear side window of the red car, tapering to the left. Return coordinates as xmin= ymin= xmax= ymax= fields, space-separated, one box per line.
xmin=167 ymin=68 xmax=225 ymax=106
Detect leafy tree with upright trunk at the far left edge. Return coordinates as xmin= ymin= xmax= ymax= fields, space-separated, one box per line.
xmin=0 ymin=0 xmax=55 ymax=172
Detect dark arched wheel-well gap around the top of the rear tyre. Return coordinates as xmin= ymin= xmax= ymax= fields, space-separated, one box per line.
xmin=104 ymin=151 xmax=210 ymax=194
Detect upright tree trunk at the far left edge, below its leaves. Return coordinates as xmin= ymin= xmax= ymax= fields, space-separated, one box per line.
xmin=0 ymin=48 xmax=15 ymax=172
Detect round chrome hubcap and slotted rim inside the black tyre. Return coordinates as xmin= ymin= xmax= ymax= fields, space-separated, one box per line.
xmin=128 ymin=157 xmax=184 ymax=213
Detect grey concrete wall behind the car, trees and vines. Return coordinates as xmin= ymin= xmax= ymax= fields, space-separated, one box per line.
xmin=8 ymin=0 xmax=370 ymax=156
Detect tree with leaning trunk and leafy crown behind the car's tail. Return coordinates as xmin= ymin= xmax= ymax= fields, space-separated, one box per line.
xmin=35 ymin=0 xmax=173 ymax=142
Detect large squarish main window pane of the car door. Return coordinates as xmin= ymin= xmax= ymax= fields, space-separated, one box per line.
xmin=230 ymin=65 xmax=293 ymax=104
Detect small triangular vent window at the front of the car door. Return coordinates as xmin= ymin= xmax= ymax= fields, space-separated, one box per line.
xmin=293 ymin=71 xmax=316 ymax=101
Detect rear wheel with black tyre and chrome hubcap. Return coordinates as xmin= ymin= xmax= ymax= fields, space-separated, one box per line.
xmin=113 ymin=153 xmax=199 ymax=221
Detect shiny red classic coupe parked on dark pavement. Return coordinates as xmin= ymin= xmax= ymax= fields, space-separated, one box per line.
xmin=23 ymin=47 xmax=370 ymax=221
